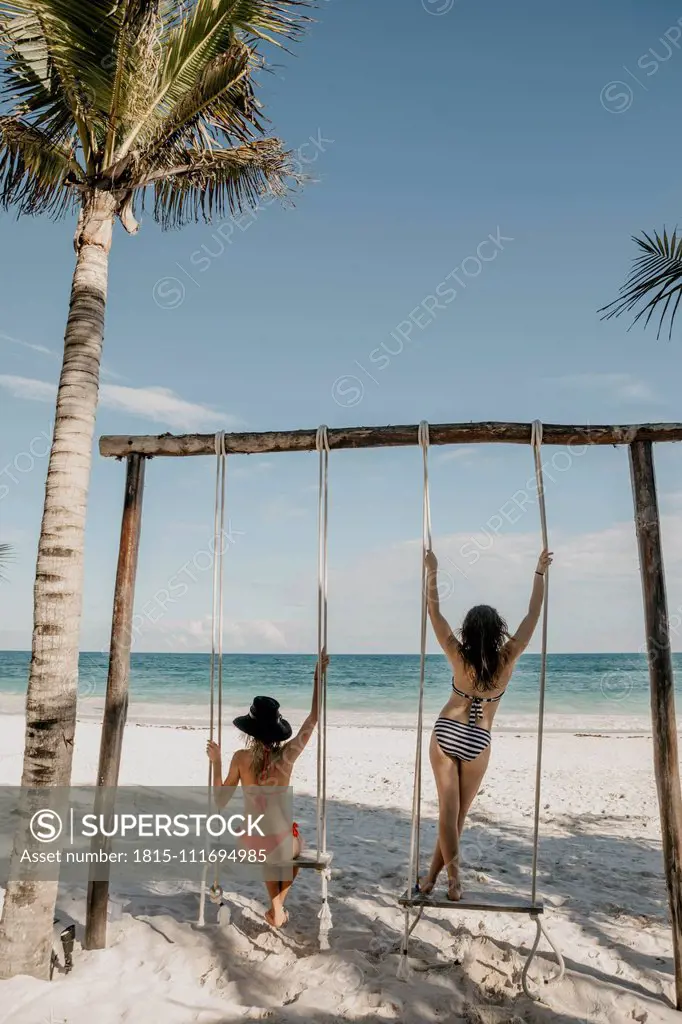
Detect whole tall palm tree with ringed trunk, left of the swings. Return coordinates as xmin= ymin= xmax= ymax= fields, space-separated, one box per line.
xmin=0 ymin=0 xmax=307 ymax=978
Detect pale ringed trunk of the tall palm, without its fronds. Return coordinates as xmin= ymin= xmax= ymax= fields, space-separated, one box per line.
xmin=0 ymin=191 xmax=116 ymax=978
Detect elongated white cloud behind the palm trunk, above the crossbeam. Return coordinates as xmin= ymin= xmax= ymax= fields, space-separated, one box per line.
xmin=0 ymin=374 xmax=231 ymax=430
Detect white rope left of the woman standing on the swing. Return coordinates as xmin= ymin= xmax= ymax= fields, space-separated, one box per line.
xmin=398 ymin=420 xmax=431 ymax=980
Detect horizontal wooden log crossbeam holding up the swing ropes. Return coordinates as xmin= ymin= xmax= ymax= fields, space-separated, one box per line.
xmin=99 ymin=422 xmax=682 ymax=459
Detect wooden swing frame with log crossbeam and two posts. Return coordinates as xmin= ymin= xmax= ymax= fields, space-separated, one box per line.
xmin=85 ymin=422 xmax=682 ymax=1010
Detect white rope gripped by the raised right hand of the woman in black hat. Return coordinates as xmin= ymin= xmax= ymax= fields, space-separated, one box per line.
xmin=315 ymin=426 xmax=332 ymax=949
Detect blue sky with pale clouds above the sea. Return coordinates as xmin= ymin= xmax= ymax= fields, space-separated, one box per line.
xmin=0 ymin=0 xmax=682 ymax=651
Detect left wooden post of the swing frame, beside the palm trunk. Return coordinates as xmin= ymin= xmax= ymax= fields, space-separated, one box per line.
xmin=85 ymin=455 xmax=145 ymax=949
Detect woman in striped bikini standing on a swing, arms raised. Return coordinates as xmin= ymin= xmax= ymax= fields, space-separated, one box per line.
xmin=419 ymin=551 xmax=552 ymax=900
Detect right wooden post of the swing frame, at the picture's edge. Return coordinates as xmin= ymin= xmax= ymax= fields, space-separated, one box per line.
xmin=630 ymin=441 xmax=682 ymax=1010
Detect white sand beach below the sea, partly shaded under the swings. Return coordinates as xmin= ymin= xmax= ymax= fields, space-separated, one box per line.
xmin=0 ymin=715 xmax=678 ymax=1024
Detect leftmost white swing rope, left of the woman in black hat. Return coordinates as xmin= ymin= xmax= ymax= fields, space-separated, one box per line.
xmin=198 ymin=430 xmax=227 ymax=927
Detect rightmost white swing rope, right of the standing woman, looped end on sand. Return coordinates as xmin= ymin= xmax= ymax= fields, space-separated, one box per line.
xmin=521 ymin=420 xmax=565 ymax=999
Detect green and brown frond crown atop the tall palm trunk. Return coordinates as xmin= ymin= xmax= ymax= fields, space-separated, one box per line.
xmin=0 ymin=0 xmax=308 ymax=230
